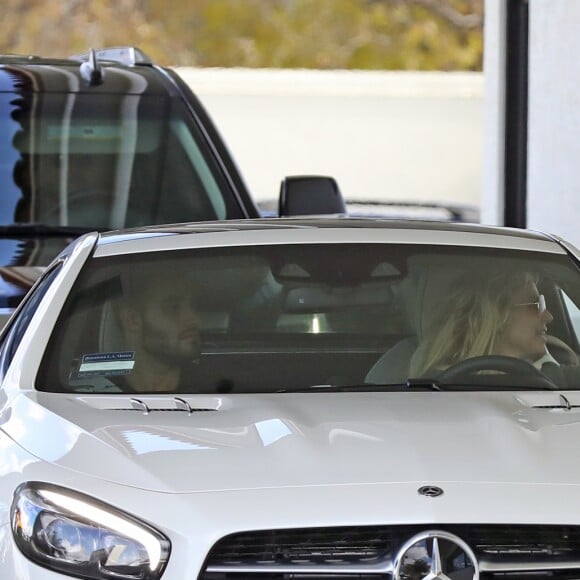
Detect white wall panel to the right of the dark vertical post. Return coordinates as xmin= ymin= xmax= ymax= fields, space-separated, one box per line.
xmin=528 ymin=0 xmax=580 ymax=247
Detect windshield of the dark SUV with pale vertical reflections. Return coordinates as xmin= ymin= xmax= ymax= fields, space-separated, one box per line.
xmin=0 ymin=92 xmax=243 ymax=230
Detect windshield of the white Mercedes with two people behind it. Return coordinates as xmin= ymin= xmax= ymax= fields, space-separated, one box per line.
xmin=36 ymin=243 xmax=580 ymax=393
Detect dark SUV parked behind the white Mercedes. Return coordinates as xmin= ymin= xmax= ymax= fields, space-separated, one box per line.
xmin=0 ymin=47 xmax=342 ymax=325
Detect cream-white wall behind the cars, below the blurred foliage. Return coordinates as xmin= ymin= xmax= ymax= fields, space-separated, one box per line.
xmin=177 ymin=68 xmax=483 ymax=206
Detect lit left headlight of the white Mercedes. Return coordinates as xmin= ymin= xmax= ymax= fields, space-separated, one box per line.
xmin=11 ymin=483 xmax=170 ymax=580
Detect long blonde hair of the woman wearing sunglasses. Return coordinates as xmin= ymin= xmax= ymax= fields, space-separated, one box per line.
xmin=410 ymin=268 xmax=536 ymax=377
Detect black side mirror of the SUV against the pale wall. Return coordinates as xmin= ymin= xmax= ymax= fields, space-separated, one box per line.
xmin=278 ymin=175 xmax=346 ymax=217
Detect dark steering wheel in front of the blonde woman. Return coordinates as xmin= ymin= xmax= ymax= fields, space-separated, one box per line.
xmin=437 ymin=355 xmax=558 ymax=389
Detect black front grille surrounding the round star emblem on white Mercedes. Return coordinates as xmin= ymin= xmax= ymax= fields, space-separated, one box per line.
xmin=199 ymin=525 xmax=580 ymax=580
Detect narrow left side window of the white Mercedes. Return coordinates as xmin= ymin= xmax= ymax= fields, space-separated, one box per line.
xmin=0 ymin=262 xmax=62 ymax=377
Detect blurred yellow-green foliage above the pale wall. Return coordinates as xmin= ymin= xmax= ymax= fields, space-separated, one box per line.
xmin=0 ymin=0 xmax=483 ymax=70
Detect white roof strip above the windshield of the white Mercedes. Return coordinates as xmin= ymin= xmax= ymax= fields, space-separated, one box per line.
xmin=95 ymin=217 xmax=566 ymax=257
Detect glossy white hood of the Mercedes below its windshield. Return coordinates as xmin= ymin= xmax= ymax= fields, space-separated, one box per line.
xmin=7 ymin=392 xmax=580 ymax=492
